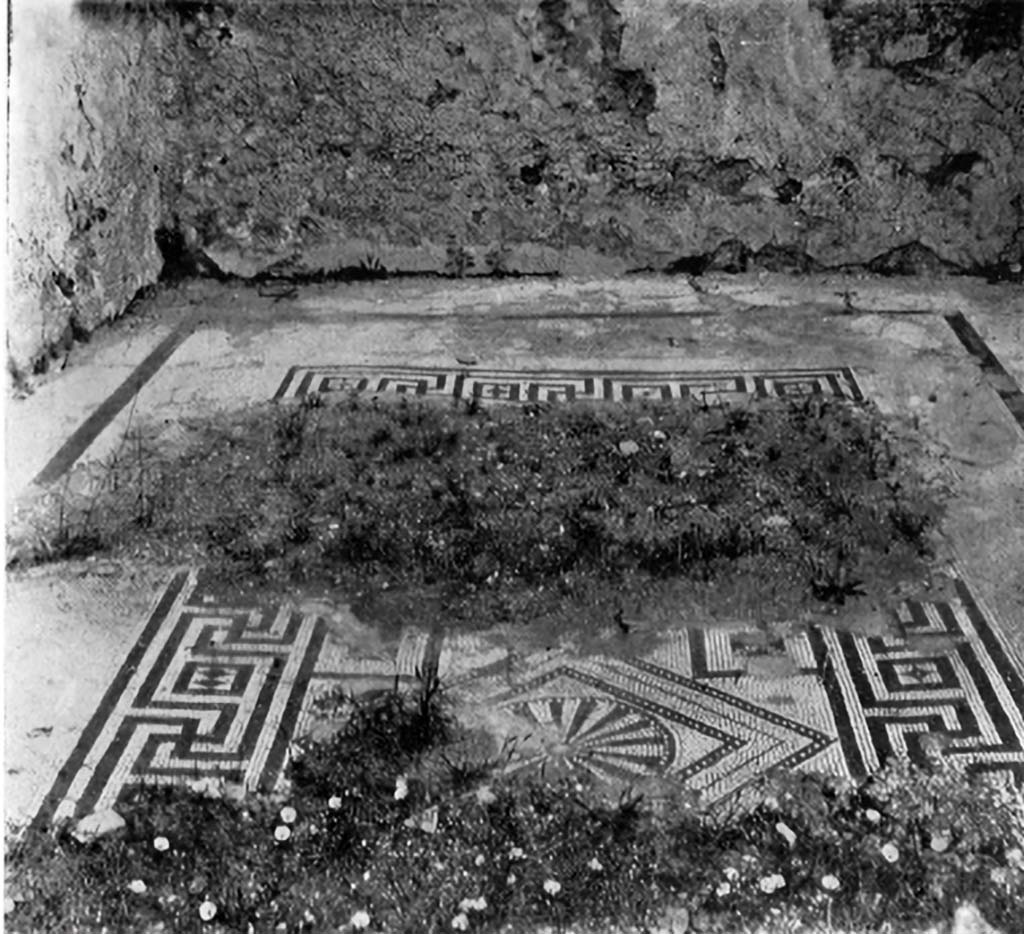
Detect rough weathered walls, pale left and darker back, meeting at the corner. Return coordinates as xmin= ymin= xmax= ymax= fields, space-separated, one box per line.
xmin=8 ymin=0 xmax=1024 ymax=372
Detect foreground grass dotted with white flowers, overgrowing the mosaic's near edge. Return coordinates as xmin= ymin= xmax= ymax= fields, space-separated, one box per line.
xmin=6 ymin=683 xmax=1024 ymax=934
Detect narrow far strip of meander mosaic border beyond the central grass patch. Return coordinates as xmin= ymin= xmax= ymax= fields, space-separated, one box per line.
xmin=273 ymin=365 xmax=864 ymax=402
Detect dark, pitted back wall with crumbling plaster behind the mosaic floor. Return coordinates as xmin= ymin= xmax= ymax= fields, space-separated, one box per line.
xmin=159 ymin=0 xmax=1024 ymax=275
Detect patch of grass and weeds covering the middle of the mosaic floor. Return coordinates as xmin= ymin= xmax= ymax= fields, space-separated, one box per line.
xmin=14 ymin=397 xmax=940 ymax=621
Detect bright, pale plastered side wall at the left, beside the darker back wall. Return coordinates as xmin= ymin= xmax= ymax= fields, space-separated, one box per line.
xmin=6 ymin=0 xmax=165 ymax=369
